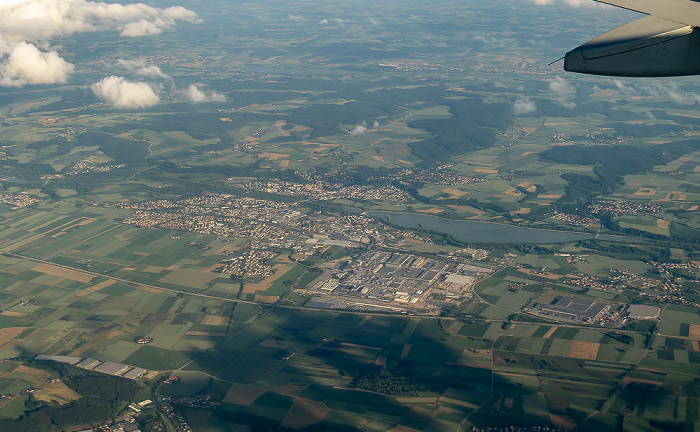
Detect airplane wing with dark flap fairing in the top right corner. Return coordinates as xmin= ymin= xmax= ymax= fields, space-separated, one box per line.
xmin=564 ymin=0 xmax=700 ymax=77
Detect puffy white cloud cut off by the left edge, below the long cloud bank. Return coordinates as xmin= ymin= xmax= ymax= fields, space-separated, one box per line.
xmin=0 ymin=42 xmax=75 ymax=87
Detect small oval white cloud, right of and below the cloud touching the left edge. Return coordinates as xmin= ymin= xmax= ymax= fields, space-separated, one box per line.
xmin=90 ymin=76 xmax=160 ymax=109
